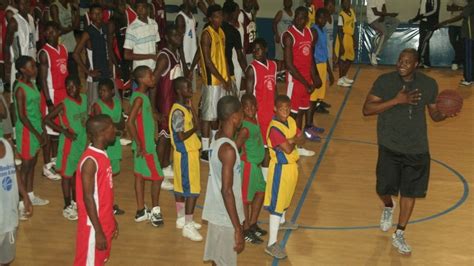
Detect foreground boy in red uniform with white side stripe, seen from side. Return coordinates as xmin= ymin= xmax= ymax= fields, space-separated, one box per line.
xmin=74 ymin=114 xmax=118 ymax=266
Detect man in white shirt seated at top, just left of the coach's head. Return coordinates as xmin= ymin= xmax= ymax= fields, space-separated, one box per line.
xmin=367 ymin=0 xmax=400 ymax=66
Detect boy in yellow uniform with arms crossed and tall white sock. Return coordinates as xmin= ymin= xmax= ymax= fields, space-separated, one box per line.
xmin=264 ymin=95 xmax=304 ymax=259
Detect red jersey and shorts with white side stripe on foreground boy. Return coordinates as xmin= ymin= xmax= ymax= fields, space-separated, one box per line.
xmin=74 ymin=146 xmax=115 ymax=266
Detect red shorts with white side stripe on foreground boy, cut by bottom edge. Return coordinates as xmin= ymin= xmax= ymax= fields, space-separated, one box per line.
xmin=74 ymin=224 xmax=113 ymax=266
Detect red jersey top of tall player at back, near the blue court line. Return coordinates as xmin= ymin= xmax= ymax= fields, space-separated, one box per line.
xmin=286 ymin=25 xmax=313 ymax=84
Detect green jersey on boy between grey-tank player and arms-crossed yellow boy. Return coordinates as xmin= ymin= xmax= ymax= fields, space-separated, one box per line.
xmin=240 ymin=119 xmax=265 ymax=164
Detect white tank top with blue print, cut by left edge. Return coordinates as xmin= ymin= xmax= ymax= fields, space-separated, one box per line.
xmin=0 ymin=138 xmax=19 ymax=235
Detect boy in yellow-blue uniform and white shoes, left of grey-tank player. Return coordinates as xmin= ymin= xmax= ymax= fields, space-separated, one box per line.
xmin=169 ymin=77 xmax=202 ymax=241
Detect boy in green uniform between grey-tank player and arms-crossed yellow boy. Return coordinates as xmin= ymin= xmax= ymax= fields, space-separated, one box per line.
xmin=235 ymin=94 xmax=267 ymax=244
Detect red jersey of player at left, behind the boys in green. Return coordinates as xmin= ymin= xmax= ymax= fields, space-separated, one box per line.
xmin=40 ymin=43 xmax=69 ymax=104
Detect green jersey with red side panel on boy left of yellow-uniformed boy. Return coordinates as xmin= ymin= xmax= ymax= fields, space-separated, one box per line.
xmin=130 ymin=91 xmax=156 ymax=153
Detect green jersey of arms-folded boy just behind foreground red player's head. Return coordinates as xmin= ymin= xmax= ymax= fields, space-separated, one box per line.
xmin=96 ymin=97 xmax=122 ymax=160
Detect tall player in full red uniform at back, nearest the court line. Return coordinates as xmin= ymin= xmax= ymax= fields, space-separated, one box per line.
xmin=282 ymin=7 xmax=321 ymax=156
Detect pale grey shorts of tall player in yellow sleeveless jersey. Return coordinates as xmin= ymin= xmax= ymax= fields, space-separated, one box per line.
xmin=200 ymin=85 xmax=231 ymax=121
